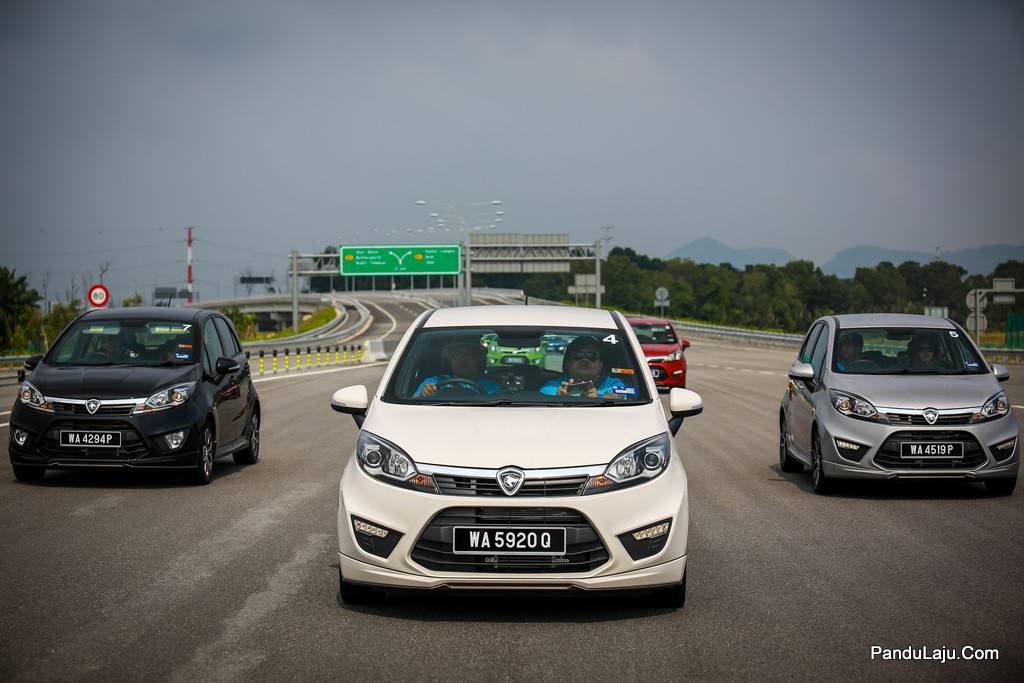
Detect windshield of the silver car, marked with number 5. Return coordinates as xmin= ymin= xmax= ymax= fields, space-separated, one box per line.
xmin=833 ymin=328 xmax=988 ymax=375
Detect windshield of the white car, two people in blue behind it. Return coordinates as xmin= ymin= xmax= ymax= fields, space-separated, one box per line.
xmin=384 ymin=327 xmax=651 ymax=407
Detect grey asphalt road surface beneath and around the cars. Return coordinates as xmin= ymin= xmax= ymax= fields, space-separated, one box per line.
xmin=0 ymin=302 xmax=1024 ymax=681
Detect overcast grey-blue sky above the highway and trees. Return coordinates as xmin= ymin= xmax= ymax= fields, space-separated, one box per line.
xmin=0 ymin=0 xmax=1024 ymax=303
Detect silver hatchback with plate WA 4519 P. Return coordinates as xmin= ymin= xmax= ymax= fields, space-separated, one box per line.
xmin=779 ymin=313 xmax=1020 ymax=495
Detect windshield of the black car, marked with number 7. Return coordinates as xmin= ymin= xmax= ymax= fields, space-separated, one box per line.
xmin=48 ymin=321 xmax=196 ymax=366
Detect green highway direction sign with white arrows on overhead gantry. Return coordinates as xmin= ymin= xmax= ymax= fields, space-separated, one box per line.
xmin=338 ymin=245 xmax=462 ymax=275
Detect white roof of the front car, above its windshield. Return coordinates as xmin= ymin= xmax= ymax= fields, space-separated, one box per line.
xmin=423 ymin=304 xmax=621 ymax=330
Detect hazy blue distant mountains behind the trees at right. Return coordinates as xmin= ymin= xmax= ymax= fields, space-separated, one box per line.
xmin=666 ymin=238 xmax=1024 ymax=279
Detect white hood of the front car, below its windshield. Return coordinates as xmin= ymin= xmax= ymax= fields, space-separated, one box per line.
xmin=362 ymin=400 xmax=668 ymax=469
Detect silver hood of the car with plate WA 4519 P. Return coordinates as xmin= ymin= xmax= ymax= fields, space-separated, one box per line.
xmin=831 ymin=375 xmax=999 ymax=410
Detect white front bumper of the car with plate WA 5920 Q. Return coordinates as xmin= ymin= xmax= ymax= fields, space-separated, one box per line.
xmin=338 ymin=458 xmax=688 ymax=591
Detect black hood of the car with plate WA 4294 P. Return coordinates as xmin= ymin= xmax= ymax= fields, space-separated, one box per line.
xmin=26 ymin=364 xmax=196 ymax=398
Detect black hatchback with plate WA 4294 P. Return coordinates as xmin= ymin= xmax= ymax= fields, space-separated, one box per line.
xmin=8 ymin=307 xmax=260 ymax=484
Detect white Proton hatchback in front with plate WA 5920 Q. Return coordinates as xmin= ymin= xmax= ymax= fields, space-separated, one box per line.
xmin=331 ymin=306 xmax=703 ymax=607
